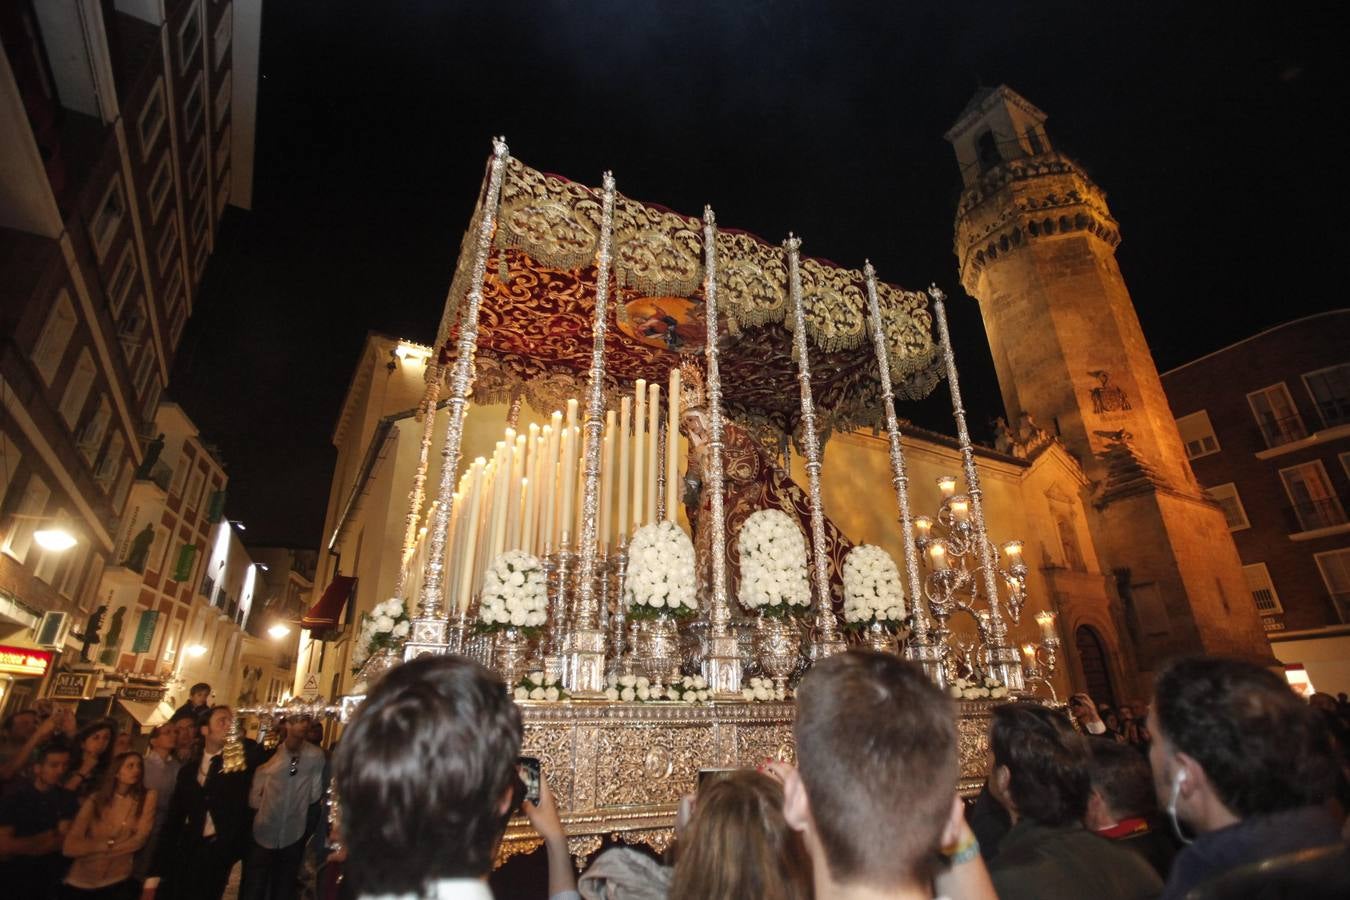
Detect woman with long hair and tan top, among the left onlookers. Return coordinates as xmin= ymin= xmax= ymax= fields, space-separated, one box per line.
xmin=61 ymin=752 xmax=155 ymax=900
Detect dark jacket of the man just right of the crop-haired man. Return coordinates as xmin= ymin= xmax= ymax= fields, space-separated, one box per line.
xmin=990 ymin=819 xmax=1162 ymax=900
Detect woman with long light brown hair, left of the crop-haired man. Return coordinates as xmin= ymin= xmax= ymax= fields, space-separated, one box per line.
xmin=670 ymin=769 xmax=811 ymax=900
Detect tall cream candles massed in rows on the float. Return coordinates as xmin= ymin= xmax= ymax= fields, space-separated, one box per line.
xmin=434 ymin=368 xmax=680 ymax=611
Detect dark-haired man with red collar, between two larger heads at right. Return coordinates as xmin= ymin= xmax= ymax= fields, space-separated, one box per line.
xmin=1083 ymin=741 xmax=1179 ymax=880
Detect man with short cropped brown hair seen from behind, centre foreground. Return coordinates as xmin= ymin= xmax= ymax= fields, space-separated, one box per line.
xmin=782 ymin=650 xmax=988 ymax=900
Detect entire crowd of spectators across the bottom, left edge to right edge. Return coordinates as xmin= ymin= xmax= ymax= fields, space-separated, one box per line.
xmin=0 ymin=650 xmax=1350 ymax=900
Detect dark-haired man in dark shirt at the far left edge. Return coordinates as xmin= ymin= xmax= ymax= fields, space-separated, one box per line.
xmin=0 ymin=742 xmax=80 ymax=900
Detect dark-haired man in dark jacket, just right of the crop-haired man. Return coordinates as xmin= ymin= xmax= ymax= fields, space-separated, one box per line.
xmin=990 ymin=703 xmax=1162 ymax=900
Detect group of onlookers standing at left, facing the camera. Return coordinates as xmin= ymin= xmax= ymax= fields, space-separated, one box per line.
xmin=0 ymin=684 xmax=329 ymax=900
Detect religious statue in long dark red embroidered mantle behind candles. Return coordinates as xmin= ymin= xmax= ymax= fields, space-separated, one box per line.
xmin=680 ymin=364 xmax=853 ymax=609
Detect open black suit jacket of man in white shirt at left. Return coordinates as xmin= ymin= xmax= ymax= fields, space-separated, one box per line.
xmin=150 ymin=754 xmax=254 ymax=881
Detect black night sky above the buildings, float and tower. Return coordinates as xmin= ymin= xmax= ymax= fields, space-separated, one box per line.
xmin=169 ymin=0 xmax=1347 ymax=546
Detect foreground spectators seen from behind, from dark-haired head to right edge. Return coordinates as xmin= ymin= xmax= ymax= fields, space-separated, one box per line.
xmin=335 ymin=650 xmax=1350 ymax=900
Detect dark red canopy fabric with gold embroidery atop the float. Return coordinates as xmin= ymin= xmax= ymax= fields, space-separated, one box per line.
xmin=437 ymin=159 xmax=940 ymax=447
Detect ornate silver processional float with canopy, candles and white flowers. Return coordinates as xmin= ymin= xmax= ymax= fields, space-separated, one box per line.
xmin=237 ymin=139 xmax=1058 ymax=855
